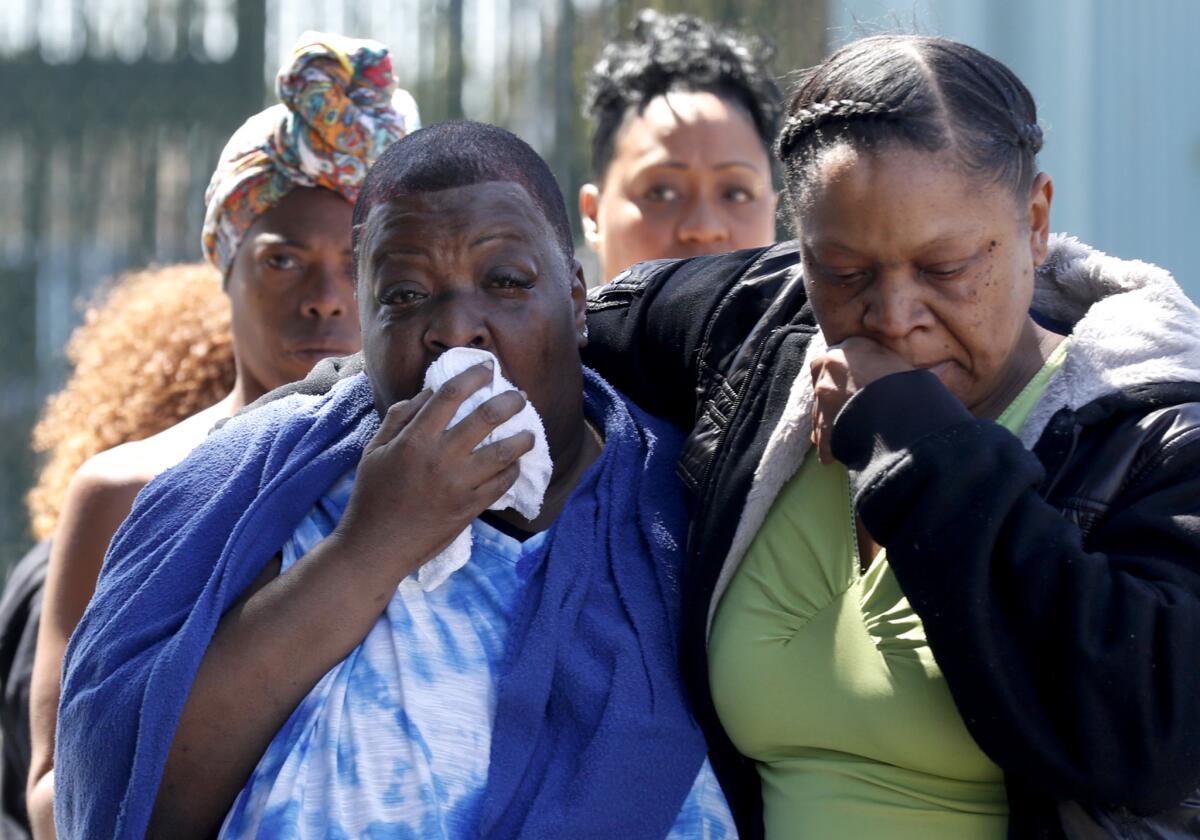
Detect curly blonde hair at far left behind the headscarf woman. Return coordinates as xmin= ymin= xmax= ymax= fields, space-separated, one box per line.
xmin=25 ymin=263 xmax=234 ymax=540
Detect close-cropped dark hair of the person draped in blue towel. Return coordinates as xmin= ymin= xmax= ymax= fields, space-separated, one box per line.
xmin=352 ymin=121 xmax=575 ymax=271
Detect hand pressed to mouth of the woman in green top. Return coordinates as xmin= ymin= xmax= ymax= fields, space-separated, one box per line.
xmin=810 ymin=336 xmax=914 ymax=463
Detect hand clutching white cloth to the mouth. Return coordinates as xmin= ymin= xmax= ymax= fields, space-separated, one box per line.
xmin=337 ymin=365 xmax=534 ymax=576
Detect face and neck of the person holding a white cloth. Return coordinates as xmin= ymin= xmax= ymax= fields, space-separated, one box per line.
xmin=359 ymin=182 xmax=599 ymax=530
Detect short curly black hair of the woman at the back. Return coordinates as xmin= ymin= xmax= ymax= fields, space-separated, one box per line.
xmin=583 ymin=10 xmax=782 ymax=184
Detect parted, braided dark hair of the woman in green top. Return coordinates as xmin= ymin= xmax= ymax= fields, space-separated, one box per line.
xmin=776 ymin=35 xmax=1042 ymax=209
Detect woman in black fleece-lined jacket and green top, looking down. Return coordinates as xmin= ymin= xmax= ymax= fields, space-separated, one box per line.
xmin=587 ymin=36 xmax=1200 ymax=840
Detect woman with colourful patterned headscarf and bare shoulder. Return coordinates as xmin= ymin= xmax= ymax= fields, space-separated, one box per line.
xmin=28 ymin=32 xmax=416 ymax=838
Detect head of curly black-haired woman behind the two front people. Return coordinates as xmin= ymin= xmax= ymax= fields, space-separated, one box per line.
xmin=580 ymin=10 xmax=781 ymax=282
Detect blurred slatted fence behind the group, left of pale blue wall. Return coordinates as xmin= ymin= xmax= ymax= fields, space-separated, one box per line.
xmin=0 ymin=0 xmax=827 ymax=569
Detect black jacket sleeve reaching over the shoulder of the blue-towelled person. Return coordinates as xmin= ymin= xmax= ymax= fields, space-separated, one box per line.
xmin=583 ymin=244 xmax=796 ymax=428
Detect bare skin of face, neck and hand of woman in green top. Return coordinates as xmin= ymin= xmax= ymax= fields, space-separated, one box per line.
xmin=797 ymin=146 xmax=1062 ymax=568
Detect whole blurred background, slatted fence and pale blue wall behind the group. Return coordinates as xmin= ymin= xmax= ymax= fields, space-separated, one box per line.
xmin=0 ymin=0 xmax=1200 ymax=569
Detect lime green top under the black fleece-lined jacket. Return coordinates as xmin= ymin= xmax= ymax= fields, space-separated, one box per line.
xmin=708 ymin=341 xmax=1067 ymax=840
